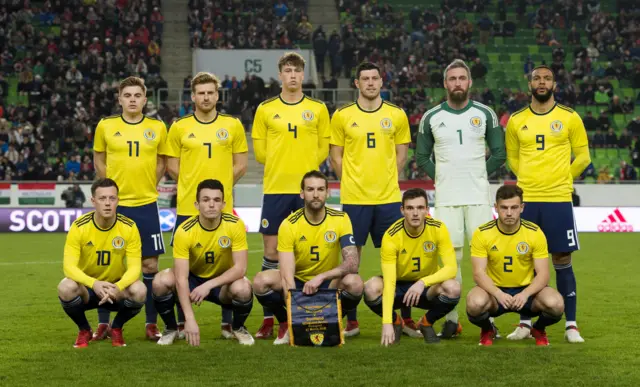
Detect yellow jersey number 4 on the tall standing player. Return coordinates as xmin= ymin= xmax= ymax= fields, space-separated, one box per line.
xmin=251 ymin=96 xmax=331 ymax=194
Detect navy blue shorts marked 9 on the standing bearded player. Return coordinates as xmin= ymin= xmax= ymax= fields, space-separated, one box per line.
xmin=522 ymin=202 xmax=580 ymax=254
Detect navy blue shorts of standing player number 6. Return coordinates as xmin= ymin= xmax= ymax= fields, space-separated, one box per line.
xmin=342 ymin=202 xmax=402 ymax=248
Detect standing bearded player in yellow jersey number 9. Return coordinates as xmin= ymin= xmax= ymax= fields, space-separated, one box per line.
xmin=506 ymin=66 xmax=591 ymax=343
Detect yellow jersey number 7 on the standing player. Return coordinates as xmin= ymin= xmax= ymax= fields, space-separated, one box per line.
xmin=167 ymin=113 xmax=249 ymax=216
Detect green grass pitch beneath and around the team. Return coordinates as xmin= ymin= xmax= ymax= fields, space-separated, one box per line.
xmin=0 ymin=234 xmax=640 ymax=387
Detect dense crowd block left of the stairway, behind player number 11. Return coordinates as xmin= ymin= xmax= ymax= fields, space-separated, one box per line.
xmin=0 ymin=0 xmax=171 ymax=180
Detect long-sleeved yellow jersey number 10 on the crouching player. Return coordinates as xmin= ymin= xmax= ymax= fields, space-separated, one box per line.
xmin=64 ymin=211 xmax=142 ymax=290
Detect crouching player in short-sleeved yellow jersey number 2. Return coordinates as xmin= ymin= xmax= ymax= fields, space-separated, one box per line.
xmin=467 ymin=185 xmax=564 ymax=345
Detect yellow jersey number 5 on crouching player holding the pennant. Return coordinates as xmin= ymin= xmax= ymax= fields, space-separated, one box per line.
xmin=278 ymin=207 xmax=355 ymax=282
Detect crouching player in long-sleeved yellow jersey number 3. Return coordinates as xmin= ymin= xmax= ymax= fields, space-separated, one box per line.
xmin=364 ymin=188 xmax=460 ymax=346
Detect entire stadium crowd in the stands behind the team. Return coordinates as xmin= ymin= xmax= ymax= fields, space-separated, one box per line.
xmin=0 ymin=0 xmax=640 ymax=180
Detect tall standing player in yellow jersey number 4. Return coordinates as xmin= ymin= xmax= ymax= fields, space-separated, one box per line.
xmin=251 ymin=52 xmax=331 ymax=339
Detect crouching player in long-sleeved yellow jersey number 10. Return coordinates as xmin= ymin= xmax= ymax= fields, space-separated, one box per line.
xmin=58 ymin=178 xmax=147 ymax=348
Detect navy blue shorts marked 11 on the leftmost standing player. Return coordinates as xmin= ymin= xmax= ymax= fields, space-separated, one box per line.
xmin=118 ymin=202 xmax=164 ymax=258
